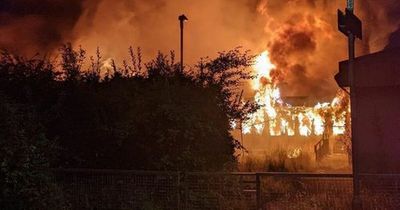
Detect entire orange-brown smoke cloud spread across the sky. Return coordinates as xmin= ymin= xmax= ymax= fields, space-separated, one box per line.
xmin=0 ymin=0 xmax=400 ymax=99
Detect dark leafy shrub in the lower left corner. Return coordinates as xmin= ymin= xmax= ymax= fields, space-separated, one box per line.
xmin=0 ymin=94 xmax=67 ymax=209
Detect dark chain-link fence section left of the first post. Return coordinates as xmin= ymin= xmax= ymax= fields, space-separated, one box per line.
xmin=55 ymin=169 xmax=180 ymax=210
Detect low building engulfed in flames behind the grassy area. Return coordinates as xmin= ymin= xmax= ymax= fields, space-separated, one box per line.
xmin=234 ymin=51 xmax=350 ymax=166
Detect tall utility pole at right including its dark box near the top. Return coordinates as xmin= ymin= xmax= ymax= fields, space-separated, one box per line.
xmin=338 ymin=0 xmax=362 ymax=210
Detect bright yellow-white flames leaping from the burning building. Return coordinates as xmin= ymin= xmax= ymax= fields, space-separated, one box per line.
xmin=242 ymin=51 xmax=348 ymax=136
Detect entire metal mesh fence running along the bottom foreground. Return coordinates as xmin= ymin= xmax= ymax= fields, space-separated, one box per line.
xmin=54 ymin=169 xmax=400 ymax=210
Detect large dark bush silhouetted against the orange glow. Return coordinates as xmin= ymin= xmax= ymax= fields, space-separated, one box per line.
xmin=0 ymin=44 xmax=258 ymax=171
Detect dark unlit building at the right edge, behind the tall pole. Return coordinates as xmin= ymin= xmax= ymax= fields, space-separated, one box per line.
xmin=335 ymin=48 xmax=400 ymax=173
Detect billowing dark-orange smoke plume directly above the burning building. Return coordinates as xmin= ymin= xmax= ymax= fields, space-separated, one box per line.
xmin=259 ymin=0 xmax=346 ymax=100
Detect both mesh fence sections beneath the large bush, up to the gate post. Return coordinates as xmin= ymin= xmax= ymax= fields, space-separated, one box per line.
xmin=54 ymin=169 xmax=256 ymax=210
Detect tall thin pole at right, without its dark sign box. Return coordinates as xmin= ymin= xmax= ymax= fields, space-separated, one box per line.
xmin=347 ymin=0 xmax=362 ymax=209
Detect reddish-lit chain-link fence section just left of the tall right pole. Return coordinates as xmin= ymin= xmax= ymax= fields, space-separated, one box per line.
xmin=259 ymin=173 xmax=353 ymax=209
